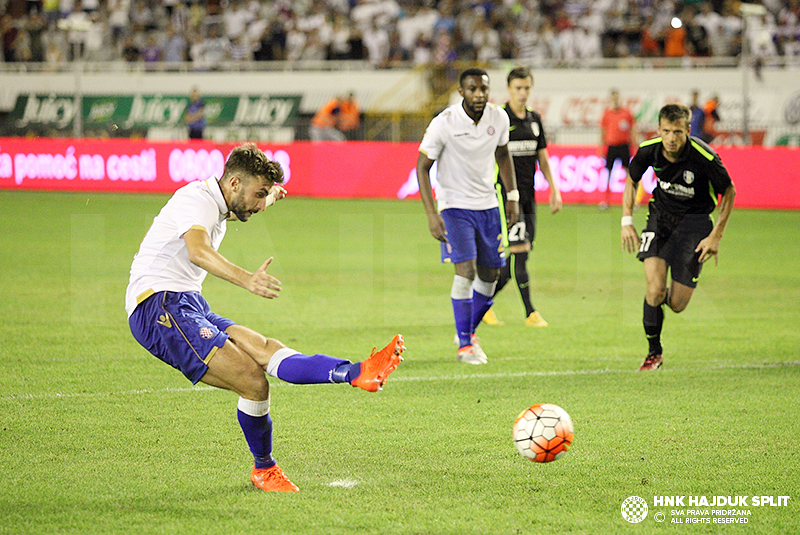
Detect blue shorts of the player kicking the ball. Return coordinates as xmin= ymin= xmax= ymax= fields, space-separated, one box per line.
xmin=128 ymin=292 xmax=235 ymax=384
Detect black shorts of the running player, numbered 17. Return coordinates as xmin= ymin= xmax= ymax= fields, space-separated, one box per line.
xmin=636 ymin=205 xmax=714 ymax=288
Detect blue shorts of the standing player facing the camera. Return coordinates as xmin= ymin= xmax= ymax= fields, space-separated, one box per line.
xmin=441 ymin=208 xmax=506 ymax=268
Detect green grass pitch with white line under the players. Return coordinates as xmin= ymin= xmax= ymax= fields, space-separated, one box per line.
xmin=0 ymin=192 xmax=800 ymax=535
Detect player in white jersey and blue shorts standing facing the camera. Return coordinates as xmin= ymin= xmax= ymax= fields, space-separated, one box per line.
xmin=417 ymin=69 xmax=519 ymax=364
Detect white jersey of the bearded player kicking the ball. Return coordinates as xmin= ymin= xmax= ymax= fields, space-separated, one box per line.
xmin=125 ymin=177 xmax=228 ymax=316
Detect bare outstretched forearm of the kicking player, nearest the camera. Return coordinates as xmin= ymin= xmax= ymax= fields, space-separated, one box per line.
xmin=183 ymin=228 xmax=281 ymax=299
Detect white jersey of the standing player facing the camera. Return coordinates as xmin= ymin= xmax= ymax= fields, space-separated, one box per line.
xmin=419 ymin=103 xmax=510 ymax=212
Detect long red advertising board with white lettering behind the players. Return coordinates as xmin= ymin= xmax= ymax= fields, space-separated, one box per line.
xmin=0 ymin=138 xmax=800 ymax=210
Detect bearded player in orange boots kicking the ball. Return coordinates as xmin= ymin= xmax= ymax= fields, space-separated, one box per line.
xmin=125 ymin=145 xmax=405 ymax=492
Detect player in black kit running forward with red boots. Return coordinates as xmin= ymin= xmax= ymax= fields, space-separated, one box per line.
xmin=621 ymin=104 xmax=736 ymax=371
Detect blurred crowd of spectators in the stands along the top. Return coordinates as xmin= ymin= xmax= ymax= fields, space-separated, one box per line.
xmin=0 ymin=0 xmax=800 ymax=69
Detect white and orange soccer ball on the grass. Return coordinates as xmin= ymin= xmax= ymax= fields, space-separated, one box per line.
xmin=514 ymin=403 xmax=575 ymax=463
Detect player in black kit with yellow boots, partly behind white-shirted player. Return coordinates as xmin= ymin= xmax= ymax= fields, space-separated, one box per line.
xmin=483 ymin=67 xmax=561 ymax=327
